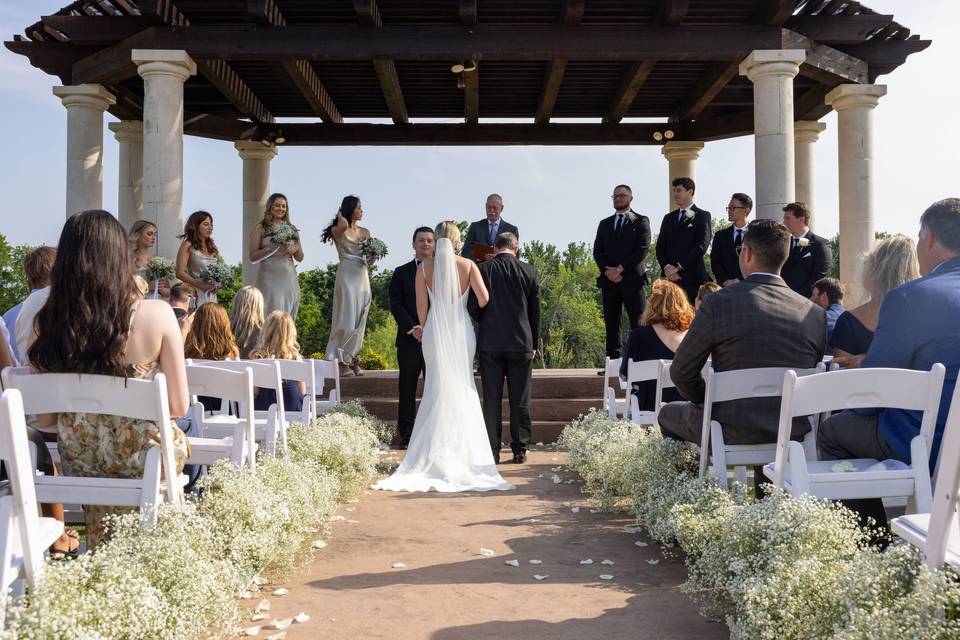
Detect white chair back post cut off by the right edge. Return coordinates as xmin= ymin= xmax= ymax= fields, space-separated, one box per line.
xmin=924 ymin=384 xmax=960 ymax=568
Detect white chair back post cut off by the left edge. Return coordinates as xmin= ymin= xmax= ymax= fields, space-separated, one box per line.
xmin=0 ymin=389 xmax=44 ymax=596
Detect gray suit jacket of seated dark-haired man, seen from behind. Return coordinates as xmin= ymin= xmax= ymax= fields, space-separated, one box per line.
xmin=670 ymin=274 xmax=827 ymax=444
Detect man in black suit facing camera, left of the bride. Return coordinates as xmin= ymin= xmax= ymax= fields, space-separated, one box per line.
xmin=390 ymin=227 xmax=434 ymax=449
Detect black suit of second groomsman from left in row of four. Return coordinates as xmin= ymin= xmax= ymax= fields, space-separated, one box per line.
xmin=657 ymin=205 xmax=710 ymax=304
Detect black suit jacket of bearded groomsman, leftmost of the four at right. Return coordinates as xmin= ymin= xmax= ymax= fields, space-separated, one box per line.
xmin=593 ymin=209 xmax=650 ymax=289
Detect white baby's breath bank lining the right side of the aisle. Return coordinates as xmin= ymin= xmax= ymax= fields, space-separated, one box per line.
xmin=560 ymin=411 xmax=960 ymax=640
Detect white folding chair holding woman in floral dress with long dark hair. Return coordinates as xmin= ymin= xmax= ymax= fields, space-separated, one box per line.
xmin=4 ymin=372 xmax=186 ymax=523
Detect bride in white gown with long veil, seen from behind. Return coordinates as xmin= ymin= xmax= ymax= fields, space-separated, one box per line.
xmin=373 ymin=221 xmax=513 ymax=493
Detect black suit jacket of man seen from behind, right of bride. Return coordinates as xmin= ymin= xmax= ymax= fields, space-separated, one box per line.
xmin=467 ymin=253 xmax=540 ymax=353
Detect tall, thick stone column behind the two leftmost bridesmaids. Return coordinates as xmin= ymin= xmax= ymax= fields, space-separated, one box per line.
xmin=132 ymin=49 xmax=197 ymax=258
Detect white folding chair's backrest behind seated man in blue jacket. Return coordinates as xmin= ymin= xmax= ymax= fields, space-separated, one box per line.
xmin=774 ymin=363 xmax=946 ymax=487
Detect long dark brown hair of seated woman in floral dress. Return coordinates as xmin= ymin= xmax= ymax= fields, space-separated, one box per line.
xmin=27 ymin=209 xmax=140 ymax=376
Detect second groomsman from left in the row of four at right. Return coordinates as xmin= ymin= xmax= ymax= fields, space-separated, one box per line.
xmin=657 ymin=178 xmax=710 ymax=304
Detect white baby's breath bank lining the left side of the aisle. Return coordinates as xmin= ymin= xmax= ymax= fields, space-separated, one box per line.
xmin=0 ymin=406 xmax=378 ymax=640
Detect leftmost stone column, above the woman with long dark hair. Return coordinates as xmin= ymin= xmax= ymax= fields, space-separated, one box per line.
xmin=53 ymin=84 xmax=117 ymax=218
